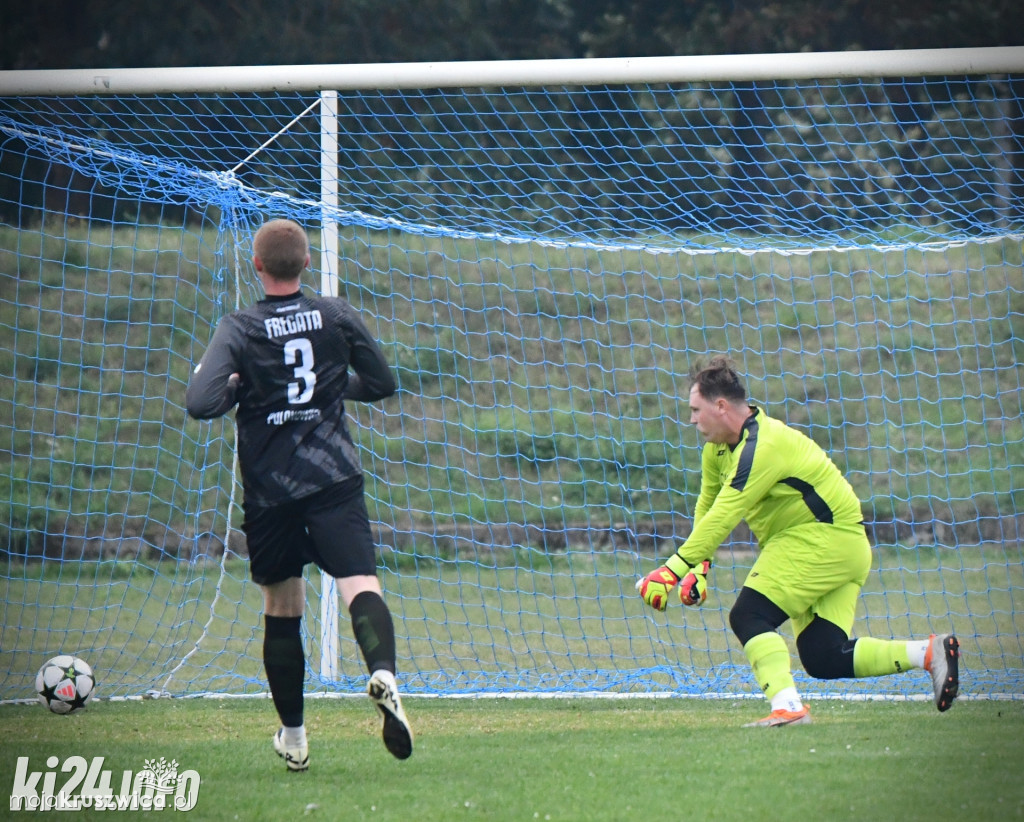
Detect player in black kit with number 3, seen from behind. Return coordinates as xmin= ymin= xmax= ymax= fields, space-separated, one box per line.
xmin=185 ymin=219 xmax=413 ymax=771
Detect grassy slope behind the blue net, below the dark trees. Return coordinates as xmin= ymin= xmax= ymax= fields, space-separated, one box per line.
xmin=0 ymin=221 xmax=1024 ymax=556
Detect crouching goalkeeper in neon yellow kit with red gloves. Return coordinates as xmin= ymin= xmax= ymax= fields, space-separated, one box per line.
xmin=637 ymin=356 xmax=959 ymax=727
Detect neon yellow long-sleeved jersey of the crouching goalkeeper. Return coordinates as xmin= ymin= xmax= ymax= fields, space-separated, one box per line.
xmin=678 ymin=406 xmax=862 ymax=565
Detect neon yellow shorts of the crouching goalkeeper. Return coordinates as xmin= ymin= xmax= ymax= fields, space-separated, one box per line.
xmin=743 ymin=522 xmax=871 ymax=636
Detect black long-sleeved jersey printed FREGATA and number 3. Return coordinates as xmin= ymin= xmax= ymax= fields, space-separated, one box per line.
xmin=185 ymin=292 xmax=396 ymax=506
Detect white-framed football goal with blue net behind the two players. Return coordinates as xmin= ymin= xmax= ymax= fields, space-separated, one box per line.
xmin=0 ymin=49 xmax=1024 ymax=699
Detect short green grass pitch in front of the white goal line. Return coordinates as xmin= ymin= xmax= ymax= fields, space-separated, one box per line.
xmin=0 ymin=697 xmax=1024 ymax=822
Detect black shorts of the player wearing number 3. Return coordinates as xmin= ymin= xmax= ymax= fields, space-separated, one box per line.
xmin=242 ymin=475 xmax=377 ymax=586
